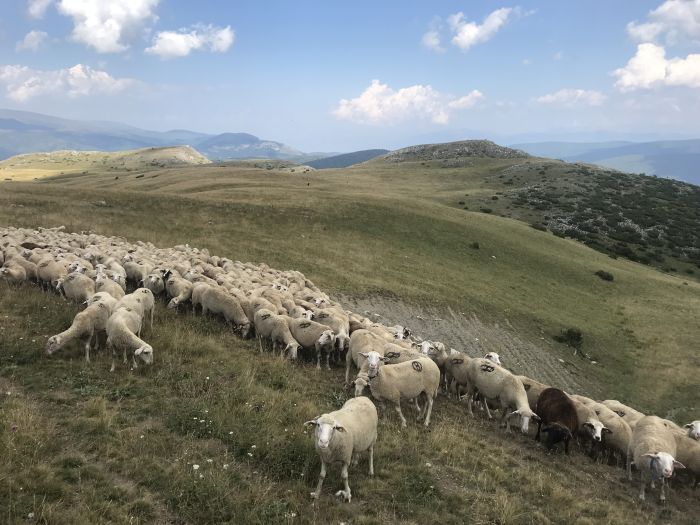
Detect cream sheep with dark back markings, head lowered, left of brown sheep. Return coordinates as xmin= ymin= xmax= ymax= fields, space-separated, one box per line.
xmin=467 ymin=358 xmax=539 ymax=434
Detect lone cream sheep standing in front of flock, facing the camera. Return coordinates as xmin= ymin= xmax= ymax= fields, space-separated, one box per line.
xmin=304 ymin=397 xmax=378 ymax=502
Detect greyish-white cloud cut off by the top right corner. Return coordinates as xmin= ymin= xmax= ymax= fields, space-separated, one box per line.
xmin=627 ymin=0 xmax=700 ymax=44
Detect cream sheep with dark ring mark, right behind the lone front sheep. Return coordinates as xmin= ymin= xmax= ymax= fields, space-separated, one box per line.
xmin=364 ymin=352 xmax=440 ymax=427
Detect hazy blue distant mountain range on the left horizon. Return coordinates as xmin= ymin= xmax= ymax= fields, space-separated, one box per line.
xmin=0 ymin=109 xmax=304 ymax=160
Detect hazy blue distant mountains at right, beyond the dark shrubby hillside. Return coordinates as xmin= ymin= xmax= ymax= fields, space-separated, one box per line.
xmin=513 ymin=139 xmax=700 ymax=185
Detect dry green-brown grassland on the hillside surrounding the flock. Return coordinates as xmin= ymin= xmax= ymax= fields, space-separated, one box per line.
xmin=0 ymin=159 xmax=700 ymax=523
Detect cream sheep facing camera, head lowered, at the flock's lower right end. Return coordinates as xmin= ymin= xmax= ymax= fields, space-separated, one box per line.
xmin=627 ymin=416 xmax=685 ymax=503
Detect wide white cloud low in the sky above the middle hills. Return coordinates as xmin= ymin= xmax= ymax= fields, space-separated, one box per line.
xmin=333 ymin=80 xmax=483 ymax=124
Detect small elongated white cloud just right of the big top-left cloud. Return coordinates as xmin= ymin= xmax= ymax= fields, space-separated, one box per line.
xmin=146 ymin=25 xmax=235 ymax=58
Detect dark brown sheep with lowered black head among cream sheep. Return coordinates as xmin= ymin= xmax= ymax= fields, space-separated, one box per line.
xmin=535 ymin=388 xmax=578 ymax=455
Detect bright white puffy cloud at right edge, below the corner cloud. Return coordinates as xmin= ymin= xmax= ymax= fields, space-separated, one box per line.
xmin=613 ymin=43 xmax=700 ymax=92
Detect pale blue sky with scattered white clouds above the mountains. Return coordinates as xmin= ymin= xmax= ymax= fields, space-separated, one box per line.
xmin=0 ymin=0 xmax=700 ymax=152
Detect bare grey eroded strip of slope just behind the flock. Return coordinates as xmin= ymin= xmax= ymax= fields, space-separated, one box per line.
xmin=335 ymin=296 xmax=602 ymax=397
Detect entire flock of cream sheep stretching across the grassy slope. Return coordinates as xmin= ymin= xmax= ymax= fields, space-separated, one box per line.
xmin=0 ymin=227 xmax=700 ymax=501
